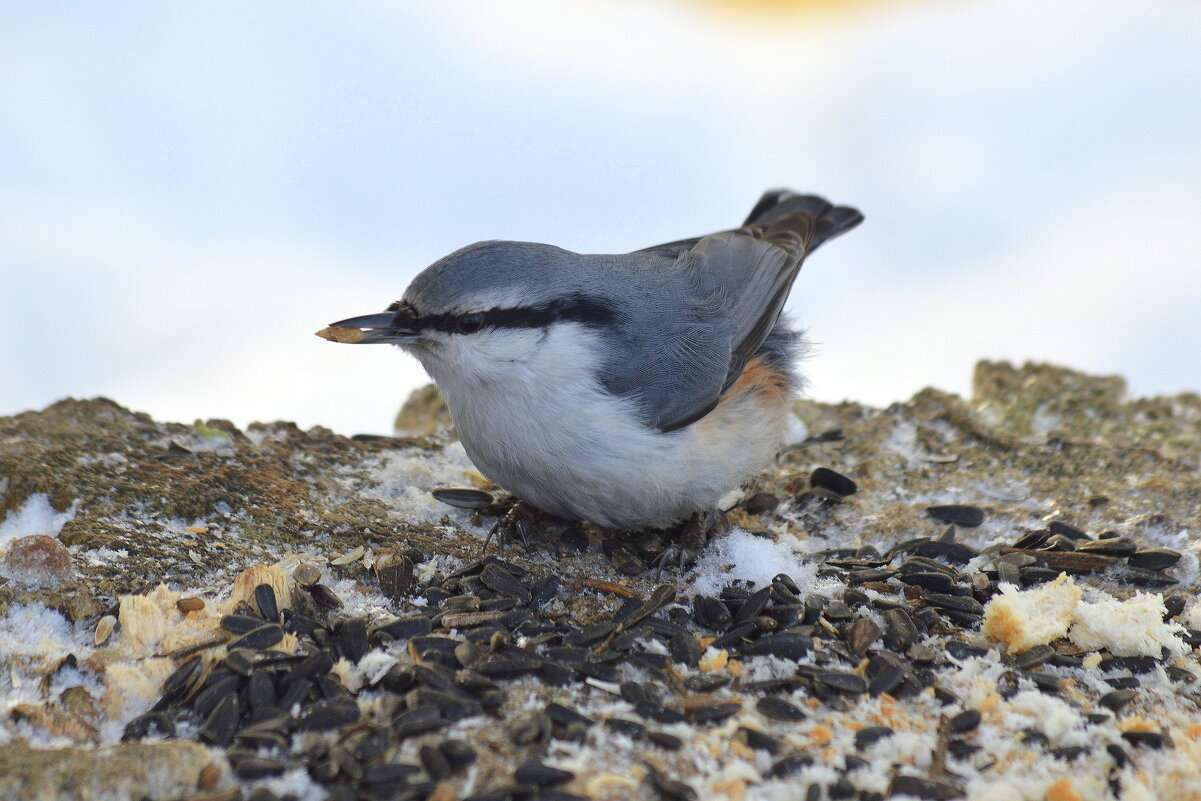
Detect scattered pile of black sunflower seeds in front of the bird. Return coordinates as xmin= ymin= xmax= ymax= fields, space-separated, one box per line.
xmin=125 ymin=468 xmax=1201 ymax=801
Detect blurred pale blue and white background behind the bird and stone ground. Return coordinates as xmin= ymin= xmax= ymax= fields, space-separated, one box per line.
xmin=0 ymin=0 xmax=1201 ymax=434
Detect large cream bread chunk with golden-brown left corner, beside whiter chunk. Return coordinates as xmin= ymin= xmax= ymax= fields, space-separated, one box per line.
xmin=984 ymin=573 xmax=1081 ymax=653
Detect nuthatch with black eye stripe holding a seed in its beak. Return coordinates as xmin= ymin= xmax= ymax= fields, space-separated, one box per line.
xmin=317 ymin=190 xmax=864 ymax=531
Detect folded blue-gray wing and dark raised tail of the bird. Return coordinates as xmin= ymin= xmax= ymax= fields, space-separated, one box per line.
xmin=604 ymin=190 xmax=862 ymax=431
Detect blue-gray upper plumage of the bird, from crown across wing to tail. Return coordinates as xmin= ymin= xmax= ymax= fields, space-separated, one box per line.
xmin=405 ymin=190 xmax=864 ymax=431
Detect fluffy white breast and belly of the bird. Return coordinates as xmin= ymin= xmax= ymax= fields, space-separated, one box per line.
xmin=423 ymin=323 xmax=785 ymax=528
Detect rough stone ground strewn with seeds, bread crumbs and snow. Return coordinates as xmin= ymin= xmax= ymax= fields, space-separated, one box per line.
xmin=0 ymin=363 xmax=1201 ymax=801
